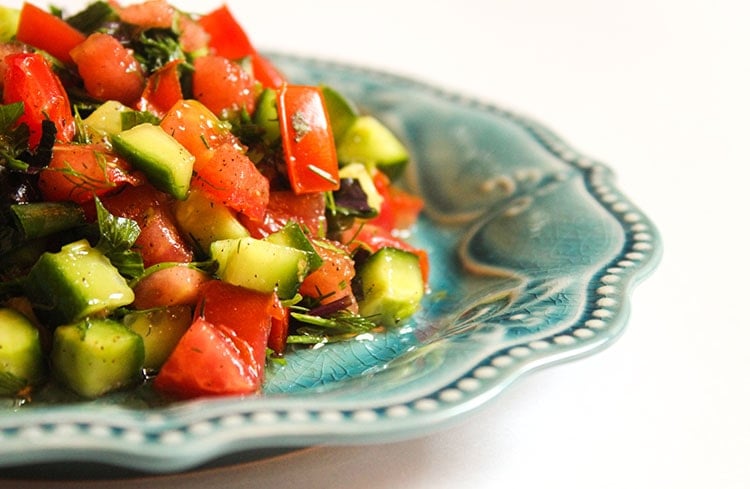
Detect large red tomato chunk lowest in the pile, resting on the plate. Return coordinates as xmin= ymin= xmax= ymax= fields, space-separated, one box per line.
xmin=154 ymin=317 xmax=265 ymax=399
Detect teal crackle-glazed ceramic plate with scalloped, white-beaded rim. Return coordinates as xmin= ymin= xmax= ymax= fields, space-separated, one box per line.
xmin=0 ymin=55 xmax=660 ymax=472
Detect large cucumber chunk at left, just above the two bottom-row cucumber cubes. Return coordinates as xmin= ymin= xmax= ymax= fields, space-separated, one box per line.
xmin=24 ymin=239 xmax=135 ymax=324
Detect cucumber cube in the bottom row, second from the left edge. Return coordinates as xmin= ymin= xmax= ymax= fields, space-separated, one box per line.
xmin=50 ymin=319 xmax=145 ymax=398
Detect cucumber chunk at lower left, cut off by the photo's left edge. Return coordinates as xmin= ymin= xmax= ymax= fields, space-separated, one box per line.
xmin=0 ymin=307 xmax=47 ymax=396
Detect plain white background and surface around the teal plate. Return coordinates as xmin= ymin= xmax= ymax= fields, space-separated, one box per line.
xmin=5 ymin=0 xmax=750 ymax=489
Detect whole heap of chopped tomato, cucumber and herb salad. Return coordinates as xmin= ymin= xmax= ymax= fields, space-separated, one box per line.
xmin=0 ymin=0 xmax=428 ymax=401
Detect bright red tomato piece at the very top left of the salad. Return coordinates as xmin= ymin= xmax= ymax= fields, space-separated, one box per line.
xmin=16 ymin=2 xmax=86 ymax=64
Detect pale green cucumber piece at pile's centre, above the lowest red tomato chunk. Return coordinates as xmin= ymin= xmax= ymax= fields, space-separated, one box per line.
xmin=211 ymin=238 xmax=310 ymax=299
